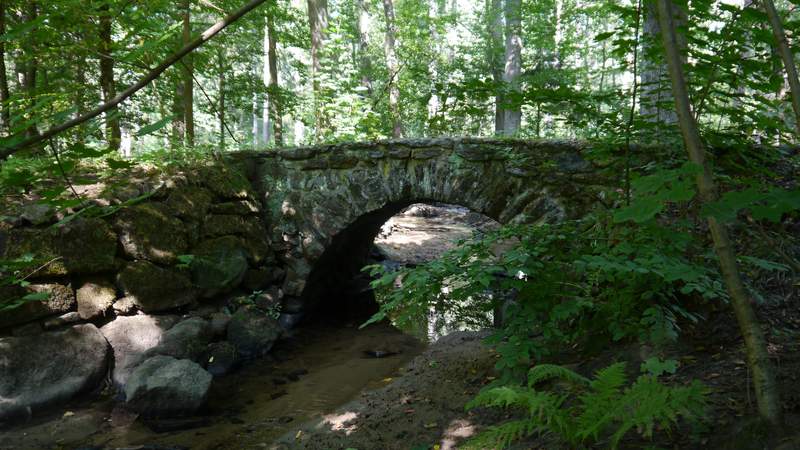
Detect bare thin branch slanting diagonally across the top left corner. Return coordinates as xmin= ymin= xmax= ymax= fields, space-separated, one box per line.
xmin=0 ymin=0 xmax=266 ymax=159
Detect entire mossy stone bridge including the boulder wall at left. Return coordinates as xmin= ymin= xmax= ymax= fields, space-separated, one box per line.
xmin=0 ymin=139 xmax=613 ymax=424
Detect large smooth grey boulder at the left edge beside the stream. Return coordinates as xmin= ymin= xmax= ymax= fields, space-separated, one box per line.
xmin=0 ymin=324 xmax=109 ymax=421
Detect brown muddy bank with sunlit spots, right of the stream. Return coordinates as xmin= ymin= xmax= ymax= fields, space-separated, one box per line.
xmin=270 ymin=332 xmax=497 ymax=450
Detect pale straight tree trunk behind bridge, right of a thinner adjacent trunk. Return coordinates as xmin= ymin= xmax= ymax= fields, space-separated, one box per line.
xmin=503 ymin=0 xmax=522 ymax=136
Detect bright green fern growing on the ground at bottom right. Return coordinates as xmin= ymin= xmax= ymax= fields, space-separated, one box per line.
xmin=466 ymin=363 xmax=707 ymax=449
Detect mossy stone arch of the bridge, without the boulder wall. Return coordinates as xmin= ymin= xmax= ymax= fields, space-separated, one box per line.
xmin=247 ymin=139 xmax=598 ymax=316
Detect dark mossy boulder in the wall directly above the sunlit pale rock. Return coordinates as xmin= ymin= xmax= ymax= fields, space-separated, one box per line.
xmin=117 ymin=261 xmax=197 ymax=313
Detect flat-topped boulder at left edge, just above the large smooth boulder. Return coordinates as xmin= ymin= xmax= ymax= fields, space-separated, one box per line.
xmin=0 ymin=283 xmax=75 ymax=328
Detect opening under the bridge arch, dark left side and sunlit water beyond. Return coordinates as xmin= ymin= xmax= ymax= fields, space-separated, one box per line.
xmin=303 ymin=200 xmax=500 ymax=338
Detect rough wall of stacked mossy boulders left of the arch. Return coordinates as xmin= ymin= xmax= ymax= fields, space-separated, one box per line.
xmin=0 ymin=161 xmax=284 ymax=423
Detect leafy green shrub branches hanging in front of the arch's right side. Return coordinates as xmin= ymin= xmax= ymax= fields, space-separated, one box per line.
xmin=365 ymin=215 xmax=726 ymax=380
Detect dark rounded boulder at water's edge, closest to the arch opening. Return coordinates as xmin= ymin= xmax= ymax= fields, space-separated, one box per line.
xmin=228 ymin=308 xmax=281 ymax=359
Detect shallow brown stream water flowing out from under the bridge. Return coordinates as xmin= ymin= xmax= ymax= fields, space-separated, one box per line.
xmin=0 ymin=324 xmax=424 ymax=449
